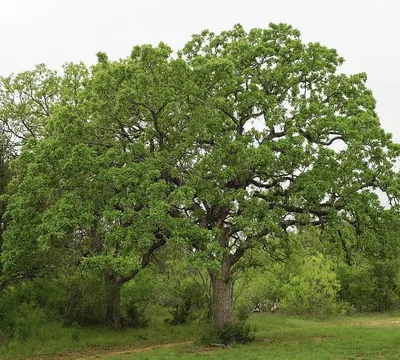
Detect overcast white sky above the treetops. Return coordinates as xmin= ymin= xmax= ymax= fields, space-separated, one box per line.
xmin=0 ymin=0 xmax=400 ymax=142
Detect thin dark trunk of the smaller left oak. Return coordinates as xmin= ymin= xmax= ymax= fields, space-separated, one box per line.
xmin=104 ymin=274 xmax=122 ymax=329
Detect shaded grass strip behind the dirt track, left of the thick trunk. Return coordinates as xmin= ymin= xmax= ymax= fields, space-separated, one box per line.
xmin=0 ymin=309 xmax=206 ymax=360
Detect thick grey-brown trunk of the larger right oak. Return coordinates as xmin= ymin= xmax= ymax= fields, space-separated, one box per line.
xmin=209 ymin=260 xmax=234 ymax=329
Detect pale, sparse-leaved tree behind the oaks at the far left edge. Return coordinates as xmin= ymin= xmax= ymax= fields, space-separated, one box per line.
xmin=0 ymin=64 xmax=60 ymax=284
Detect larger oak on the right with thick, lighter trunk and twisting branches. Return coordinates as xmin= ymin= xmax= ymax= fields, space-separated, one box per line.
xmin=177 ymin=25 xmax=398 ymax=327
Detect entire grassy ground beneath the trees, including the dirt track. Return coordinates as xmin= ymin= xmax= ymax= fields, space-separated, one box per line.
xmin=0 ymin=314 xmax=400 ymax=360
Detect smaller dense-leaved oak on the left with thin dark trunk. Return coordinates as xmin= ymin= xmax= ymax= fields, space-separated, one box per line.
xmin=4 ymin=45 xmax=185 ymax=327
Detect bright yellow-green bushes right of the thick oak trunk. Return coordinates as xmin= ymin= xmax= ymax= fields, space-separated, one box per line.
xmin=235 ymin=228 xmax=350 ymax=319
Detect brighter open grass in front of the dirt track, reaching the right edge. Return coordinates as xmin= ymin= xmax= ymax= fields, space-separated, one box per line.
xmin=106 ymin=315 xmax=400 ymax=360
